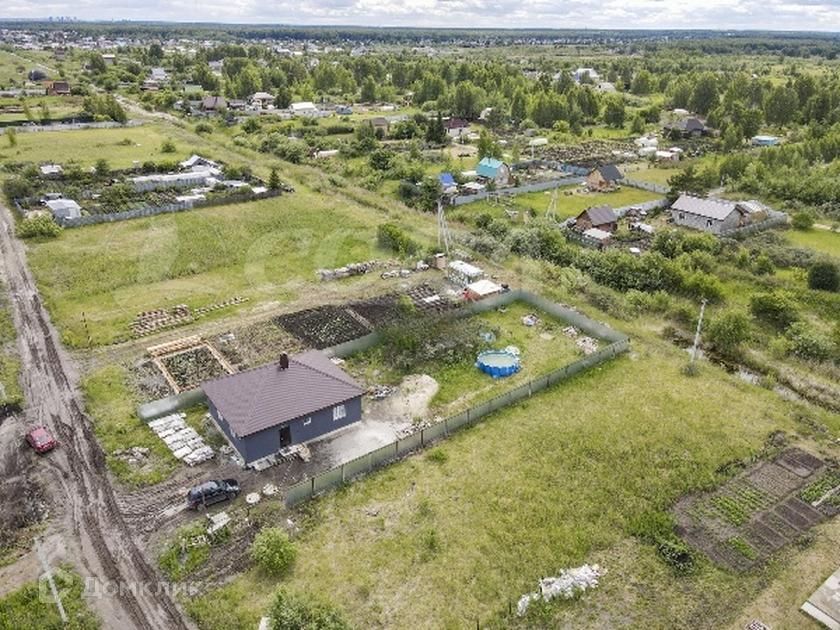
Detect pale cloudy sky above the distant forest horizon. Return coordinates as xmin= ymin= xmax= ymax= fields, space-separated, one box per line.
xmin=0 ymin=0 xmax=840 ymax=32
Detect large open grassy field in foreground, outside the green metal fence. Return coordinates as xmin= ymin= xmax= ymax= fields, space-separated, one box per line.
xmin=184 ymin=314 xmax=840 ymax=628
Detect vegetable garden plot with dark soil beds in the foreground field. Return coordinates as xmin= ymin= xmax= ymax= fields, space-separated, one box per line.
xmin=673 ymin=448 xmax=840 ymax=570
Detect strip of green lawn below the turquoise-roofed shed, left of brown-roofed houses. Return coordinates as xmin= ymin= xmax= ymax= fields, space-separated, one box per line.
xmin=448 ymin=186 xmax=661 ymax=225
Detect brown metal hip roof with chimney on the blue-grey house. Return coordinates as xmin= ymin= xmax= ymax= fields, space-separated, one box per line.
xmin=201 ymin=350 xmax=364 ymax=437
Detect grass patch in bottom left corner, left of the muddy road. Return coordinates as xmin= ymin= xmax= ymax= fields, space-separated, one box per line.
xmin=0 ymin=569 xmax=101 ymax=630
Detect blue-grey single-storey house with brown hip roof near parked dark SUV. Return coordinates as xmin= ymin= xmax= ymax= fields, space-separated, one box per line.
xmin=201 ymin=351 xmax=364 ymax=465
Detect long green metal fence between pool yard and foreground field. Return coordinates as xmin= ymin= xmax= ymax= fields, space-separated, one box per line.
xmin=286 ymin=336 xmax=630 ymax=507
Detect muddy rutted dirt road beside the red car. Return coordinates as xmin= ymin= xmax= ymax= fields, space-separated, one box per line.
xmin=0 ymin=206 xmax=191 ymax=630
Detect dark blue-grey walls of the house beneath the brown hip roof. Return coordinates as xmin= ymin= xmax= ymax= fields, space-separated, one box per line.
xmin=208 ymin=396 xmax=362 ymax=464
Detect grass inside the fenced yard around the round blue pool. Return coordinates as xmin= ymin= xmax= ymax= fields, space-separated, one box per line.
xmin=348 ymin=302 xmax=583 ymax=415
